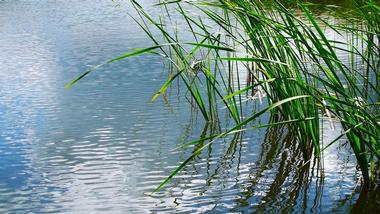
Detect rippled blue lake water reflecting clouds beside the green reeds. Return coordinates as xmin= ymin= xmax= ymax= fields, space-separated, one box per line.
xmin=0 ymin=0 xmax=372 ymax=213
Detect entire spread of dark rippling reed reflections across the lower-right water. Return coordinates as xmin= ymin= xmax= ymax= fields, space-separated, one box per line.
xmin=181 ymin=107 xmax=380 ymax=213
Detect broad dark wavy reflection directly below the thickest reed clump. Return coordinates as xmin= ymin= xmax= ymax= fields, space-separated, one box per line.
xmin=229 ymin=115 xmax=323 ymax=212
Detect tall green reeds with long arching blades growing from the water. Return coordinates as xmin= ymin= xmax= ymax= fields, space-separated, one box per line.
xmin=66 ymin=0 xmax=380 ymax=210
